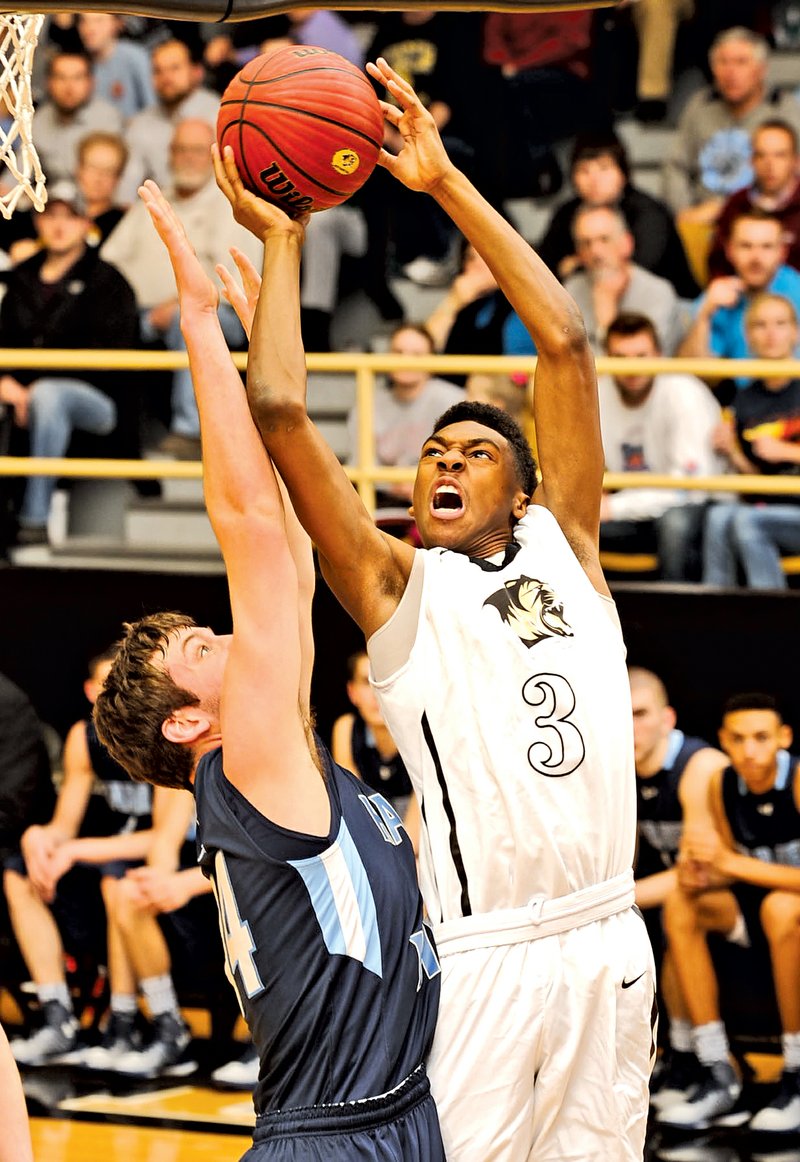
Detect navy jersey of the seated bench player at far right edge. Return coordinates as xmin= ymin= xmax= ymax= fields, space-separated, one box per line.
xmin=722 ymin=751 xmax=800 ymax=867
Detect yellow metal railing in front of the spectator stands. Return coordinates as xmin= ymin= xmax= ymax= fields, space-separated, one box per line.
xmin=0 ymin=349 xmax=800 ymax=511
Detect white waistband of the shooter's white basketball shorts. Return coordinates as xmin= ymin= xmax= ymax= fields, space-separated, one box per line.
xmin=434 ymin=870 xmax=635 ymax=956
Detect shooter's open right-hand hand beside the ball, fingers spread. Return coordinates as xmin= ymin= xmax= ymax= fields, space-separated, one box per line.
xmin=366 ymin=57 xmax=455 ymax=193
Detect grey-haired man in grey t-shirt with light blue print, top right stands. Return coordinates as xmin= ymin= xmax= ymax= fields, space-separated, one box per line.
xmin=664 ymin=27 xmax=800 ymax=224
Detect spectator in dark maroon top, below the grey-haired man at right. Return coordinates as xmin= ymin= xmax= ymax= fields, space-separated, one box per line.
xmin=708 ymin=119 xmax=800 ymax=279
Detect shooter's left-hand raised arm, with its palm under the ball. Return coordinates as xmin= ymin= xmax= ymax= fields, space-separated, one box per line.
xmin=214 ymin=148 xmax=414 ymax=636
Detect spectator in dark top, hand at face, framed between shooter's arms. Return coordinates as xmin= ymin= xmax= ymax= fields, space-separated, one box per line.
xmin=426 ymin=245 xmax=510 ymax=383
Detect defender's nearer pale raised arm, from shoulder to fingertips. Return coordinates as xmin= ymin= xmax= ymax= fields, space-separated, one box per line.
xmin=141 ymin=182 xmax=328 ymax=830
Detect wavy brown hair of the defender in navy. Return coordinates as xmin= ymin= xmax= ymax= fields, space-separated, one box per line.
xmin=94 ymin=614 xmax=200 ymax=789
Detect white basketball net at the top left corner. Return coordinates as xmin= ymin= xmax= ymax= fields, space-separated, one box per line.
xmin=0 ymin=13 xmax=47 ymax=217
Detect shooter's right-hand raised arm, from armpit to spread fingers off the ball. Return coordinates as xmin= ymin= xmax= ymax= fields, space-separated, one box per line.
xmin=367 ymin=59 xmax=606 ymax=590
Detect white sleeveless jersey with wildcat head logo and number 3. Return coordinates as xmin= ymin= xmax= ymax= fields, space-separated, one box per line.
xmin=370 ymin=505 xmax=636 ymax=923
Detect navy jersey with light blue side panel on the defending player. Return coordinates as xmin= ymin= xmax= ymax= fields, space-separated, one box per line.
xmin=194 ymin=744 xmax=440 ymax=1114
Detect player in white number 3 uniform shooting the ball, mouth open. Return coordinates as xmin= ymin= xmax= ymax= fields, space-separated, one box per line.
xmin=216 ymin=60 xmax=655 ymax=1162
